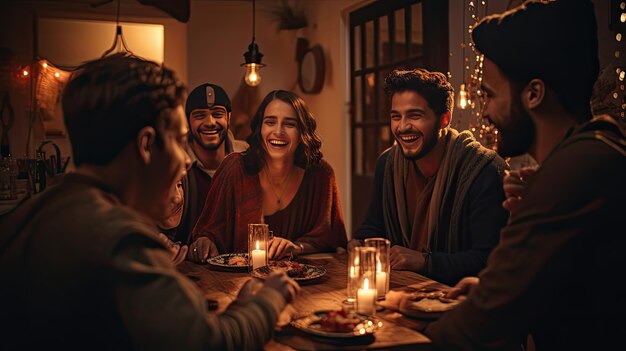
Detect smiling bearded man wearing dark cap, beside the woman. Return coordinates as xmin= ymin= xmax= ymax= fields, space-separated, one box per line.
xmin=167 ymin=83 xmax=248 ymax=255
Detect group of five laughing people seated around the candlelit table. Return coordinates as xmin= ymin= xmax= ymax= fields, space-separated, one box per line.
xmin=0 ymin=0 xmax=626 ymax=350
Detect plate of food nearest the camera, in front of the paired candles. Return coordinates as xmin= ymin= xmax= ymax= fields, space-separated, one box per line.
xmin=291 ymin=310 xmax=383 ymax=338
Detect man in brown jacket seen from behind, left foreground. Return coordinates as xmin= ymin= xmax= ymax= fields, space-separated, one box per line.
xmin=0 ymin=54 xmax=298 ymax=350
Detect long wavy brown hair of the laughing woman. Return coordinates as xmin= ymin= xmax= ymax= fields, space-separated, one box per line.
xmin=243 ymin=90 xmax=322 ymax=174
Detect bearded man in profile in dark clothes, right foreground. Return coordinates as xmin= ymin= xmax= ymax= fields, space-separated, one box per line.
xmin=426 ymin=0 xmax=626 ymax=350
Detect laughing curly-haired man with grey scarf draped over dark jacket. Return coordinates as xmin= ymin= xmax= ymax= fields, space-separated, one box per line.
xmin=351 ymin=69 xmax=508 ymax=284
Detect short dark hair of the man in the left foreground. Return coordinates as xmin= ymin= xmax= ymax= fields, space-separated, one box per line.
xmin=62 ymin=53 xmax=186 ymax=166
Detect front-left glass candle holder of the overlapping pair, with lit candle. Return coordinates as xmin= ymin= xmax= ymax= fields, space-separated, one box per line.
xmin=355 ymin=246 xmax=378 ymax=315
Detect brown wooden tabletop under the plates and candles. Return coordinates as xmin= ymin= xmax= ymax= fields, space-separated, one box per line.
xmin=178 ymin=254 xmax=449 ymax=350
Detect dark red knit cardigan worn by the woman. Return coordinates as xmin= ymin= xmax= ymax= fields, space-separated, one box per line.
xmin=193 ymin=153 xmax=347 ymax=253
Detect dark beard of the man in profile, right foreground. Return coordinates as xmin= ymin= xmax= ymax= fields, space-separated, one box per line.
xmin=496 ymin=94 xmax=535 ymax=157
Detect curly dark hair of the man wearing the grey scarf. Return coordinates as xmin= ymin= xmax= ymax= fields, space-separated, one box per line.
xmin=384 ymin=68 xmax=454 ymax=116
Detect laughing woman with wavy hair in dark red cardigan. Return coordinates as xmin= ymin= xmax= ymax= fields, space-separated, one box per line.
xmin=192 ymin=90 xmax=346 ymax=259
